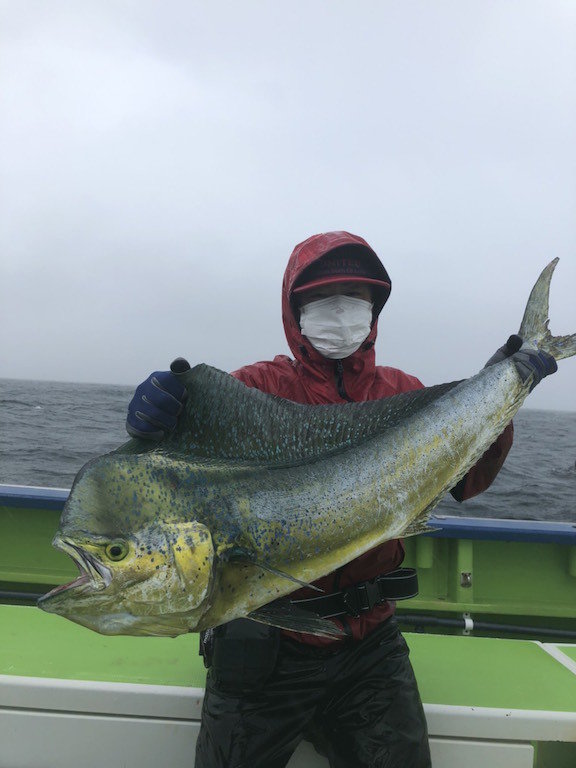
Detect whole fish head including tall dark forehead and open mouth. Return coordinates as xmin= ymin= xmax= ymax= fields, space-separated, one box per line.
xmin=39 ymin=453 xmax=214 ymax=636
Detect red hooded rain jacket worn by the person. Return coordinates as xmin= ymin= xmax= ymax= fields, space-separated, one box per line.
xmin=233 ymin=232 xmax=513 ymax=646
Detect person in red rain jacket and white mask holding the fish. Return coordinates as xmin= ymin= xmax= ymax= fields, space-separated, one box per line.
xmin=127 ymin=232 xmax=556 ymax=768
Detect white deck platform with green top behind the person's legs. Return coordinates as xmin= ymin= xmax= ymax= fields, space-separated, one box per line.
xmin=0 ymin=605 xmax=576 ymax=768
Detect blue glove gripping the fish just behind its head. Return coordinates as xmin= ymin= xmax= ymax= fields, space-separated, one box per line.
xmin=126 ymin=364 xmax=186 ymax=440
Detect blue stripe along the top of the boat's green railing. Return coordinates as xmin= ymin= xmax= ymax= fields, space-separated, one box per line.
xmin=0 ymin=484 xmax=576 ymax=545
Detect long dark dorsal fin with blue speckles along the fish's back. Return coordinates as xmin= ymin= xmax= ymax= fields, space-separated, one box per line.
xmin=136 ymin=365 xmax=458 ymax=465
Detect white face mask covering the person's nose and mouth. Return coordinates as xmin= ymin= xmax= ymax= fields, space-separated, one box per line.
xmin=300 ymin=294 xmax=372 ymax=360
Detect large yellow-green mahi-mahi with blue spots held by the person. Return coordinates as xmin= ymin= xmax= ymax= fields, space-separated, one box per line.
xmin=39 ymin=259 xmax=576 ymax=636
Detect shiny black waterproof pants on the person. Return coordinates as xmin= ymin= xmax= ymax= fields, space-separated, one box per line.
xmin=195 ymin=618 xmax=431 ymax=768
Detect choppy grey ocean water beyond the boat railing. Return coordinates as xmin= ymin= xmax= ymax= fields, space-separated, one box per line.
xmin=0 ymin=379 xmax=576 ymax=522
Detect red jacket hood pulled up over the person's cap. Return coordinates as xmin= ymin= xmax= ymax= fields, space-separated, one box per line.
xmin=282 ymin=231 xmax=392 ymax=372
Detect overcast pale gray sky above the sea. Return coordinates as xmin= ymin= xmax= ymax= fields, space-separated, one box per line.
xmin=0 ymin=0 xmax=576 ymax=410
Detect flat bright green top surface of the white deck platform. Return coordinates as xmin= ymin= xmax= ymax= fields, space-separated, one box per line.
xmin=0 ymin=605 xmax=576 ymax=712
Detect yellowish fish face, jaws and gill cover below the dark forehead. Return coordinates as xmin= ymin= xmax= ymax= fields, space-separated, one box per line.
xmin=38 ymin=521 xmax=214 ymax=636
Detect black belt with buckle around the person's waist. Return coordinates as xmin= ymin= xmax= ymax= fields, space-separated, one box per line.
xmin=290 ymin=568 xmax=418 ymax=619
